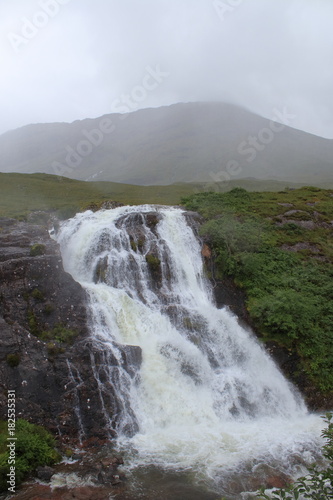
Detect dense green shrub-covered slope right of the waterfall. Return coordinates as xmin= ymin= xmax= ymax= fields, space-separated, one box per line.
xmin=183 ymin=187 xmax=333 ymax=392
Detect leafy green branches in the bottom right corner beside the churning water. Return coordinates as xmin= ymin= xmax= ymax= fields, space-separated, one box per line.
xmin=257 ymin=414 xmax=333 ymax=500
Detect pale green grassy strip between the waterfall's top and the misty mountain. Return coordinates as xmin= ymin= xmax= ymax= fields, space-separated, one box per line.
xmin=0 ymin=173 xmax=316 ymax=218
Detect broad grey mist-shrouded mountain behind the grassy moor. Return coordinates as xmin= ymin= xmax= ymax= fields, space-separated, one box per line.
xmin=0 ymin=103 xmax=333 ymax=185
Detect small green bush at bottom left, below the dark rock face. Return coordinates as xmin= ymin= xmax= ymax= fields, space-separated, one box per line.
xmin=0 ymin=419 xmax=61 ymax=492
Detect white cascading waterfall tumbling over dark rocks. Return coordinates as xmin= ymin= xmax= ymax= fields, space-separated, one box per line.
xmin=57 ymin=205 xmax=321 ymax=496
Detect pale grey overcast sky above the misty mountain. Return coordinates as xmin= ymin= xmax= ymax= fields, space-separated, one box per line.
xmin=0 ymin=0 xmax=333 ymax=138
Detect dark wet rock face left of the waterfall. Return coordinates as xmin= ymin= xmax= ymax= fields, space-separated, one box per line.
xmin=0 ymin=218 xmax=141 ymax=438
